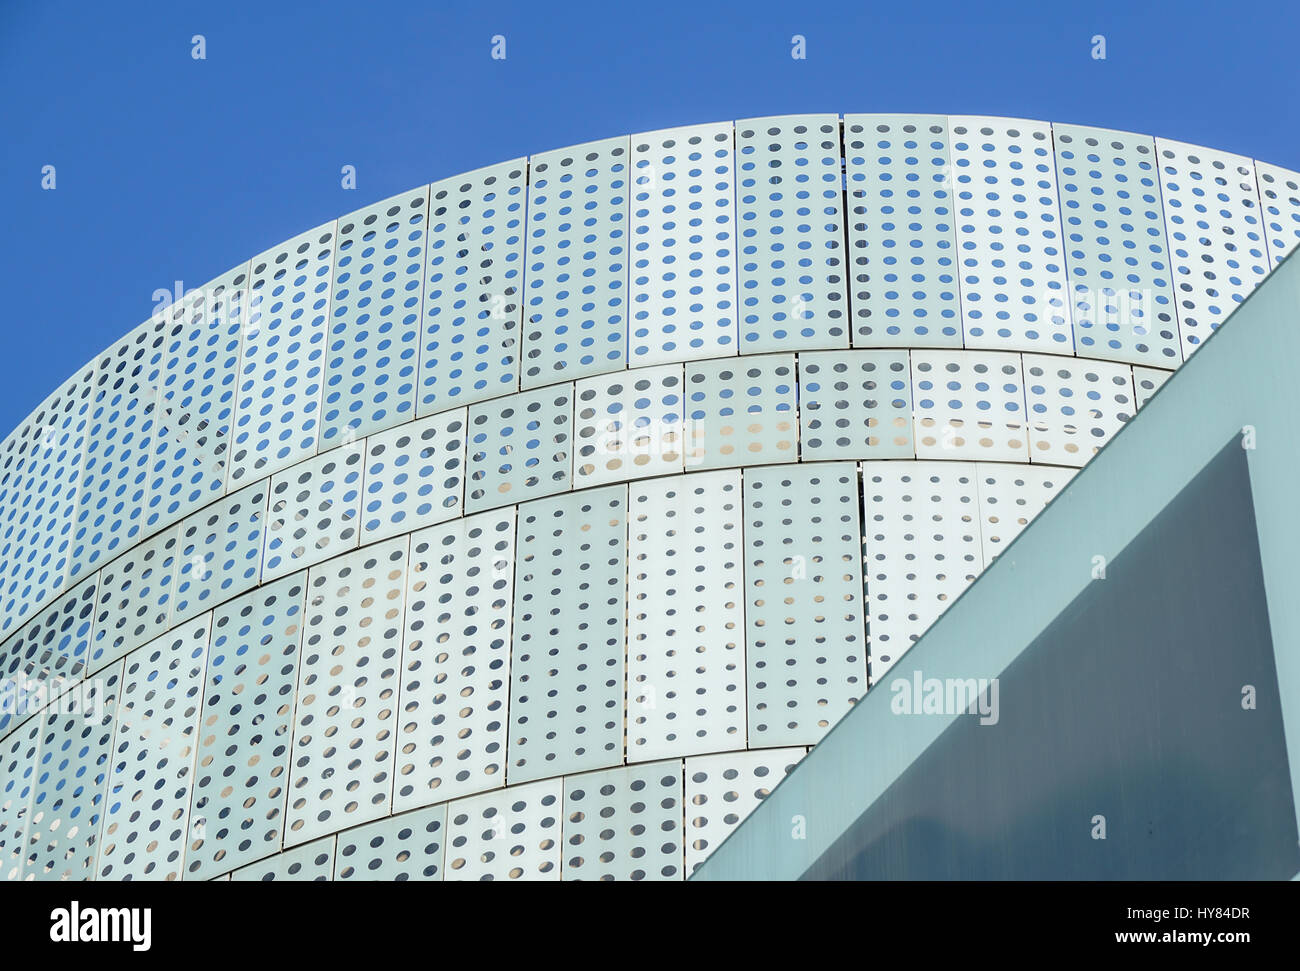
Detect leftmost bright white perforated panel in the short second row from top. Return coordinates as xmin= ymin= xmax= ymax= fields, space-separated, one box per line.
xmin=261 ymin=442 xmax=365 ymax=582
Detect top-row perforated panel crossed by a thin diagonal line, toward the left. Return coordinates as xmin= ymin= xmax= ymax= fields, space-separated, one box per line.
xmin=144 ymin=264 xmax=248 ymax=532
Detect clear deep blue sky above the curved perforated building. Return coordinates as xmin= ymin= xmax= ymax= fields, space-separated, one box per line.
xmin=0 ymin=0 xmax=1300 ymax=435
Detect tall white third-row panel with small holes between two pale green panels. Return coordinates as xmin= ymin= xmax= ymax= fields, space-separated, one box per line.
xmin=627 ymin=469 xmax=745 ymax=762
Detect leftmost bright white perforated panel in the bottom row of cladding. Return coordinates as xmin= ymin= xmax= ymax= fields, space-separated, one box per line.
xmin=443 ymin=779 xmax=564 ymax=880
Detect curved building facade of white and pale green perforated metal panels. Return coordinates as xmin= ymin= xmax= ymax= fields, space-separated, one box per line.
xmin=0 ymin=114 xmax=1300 ymax=880
